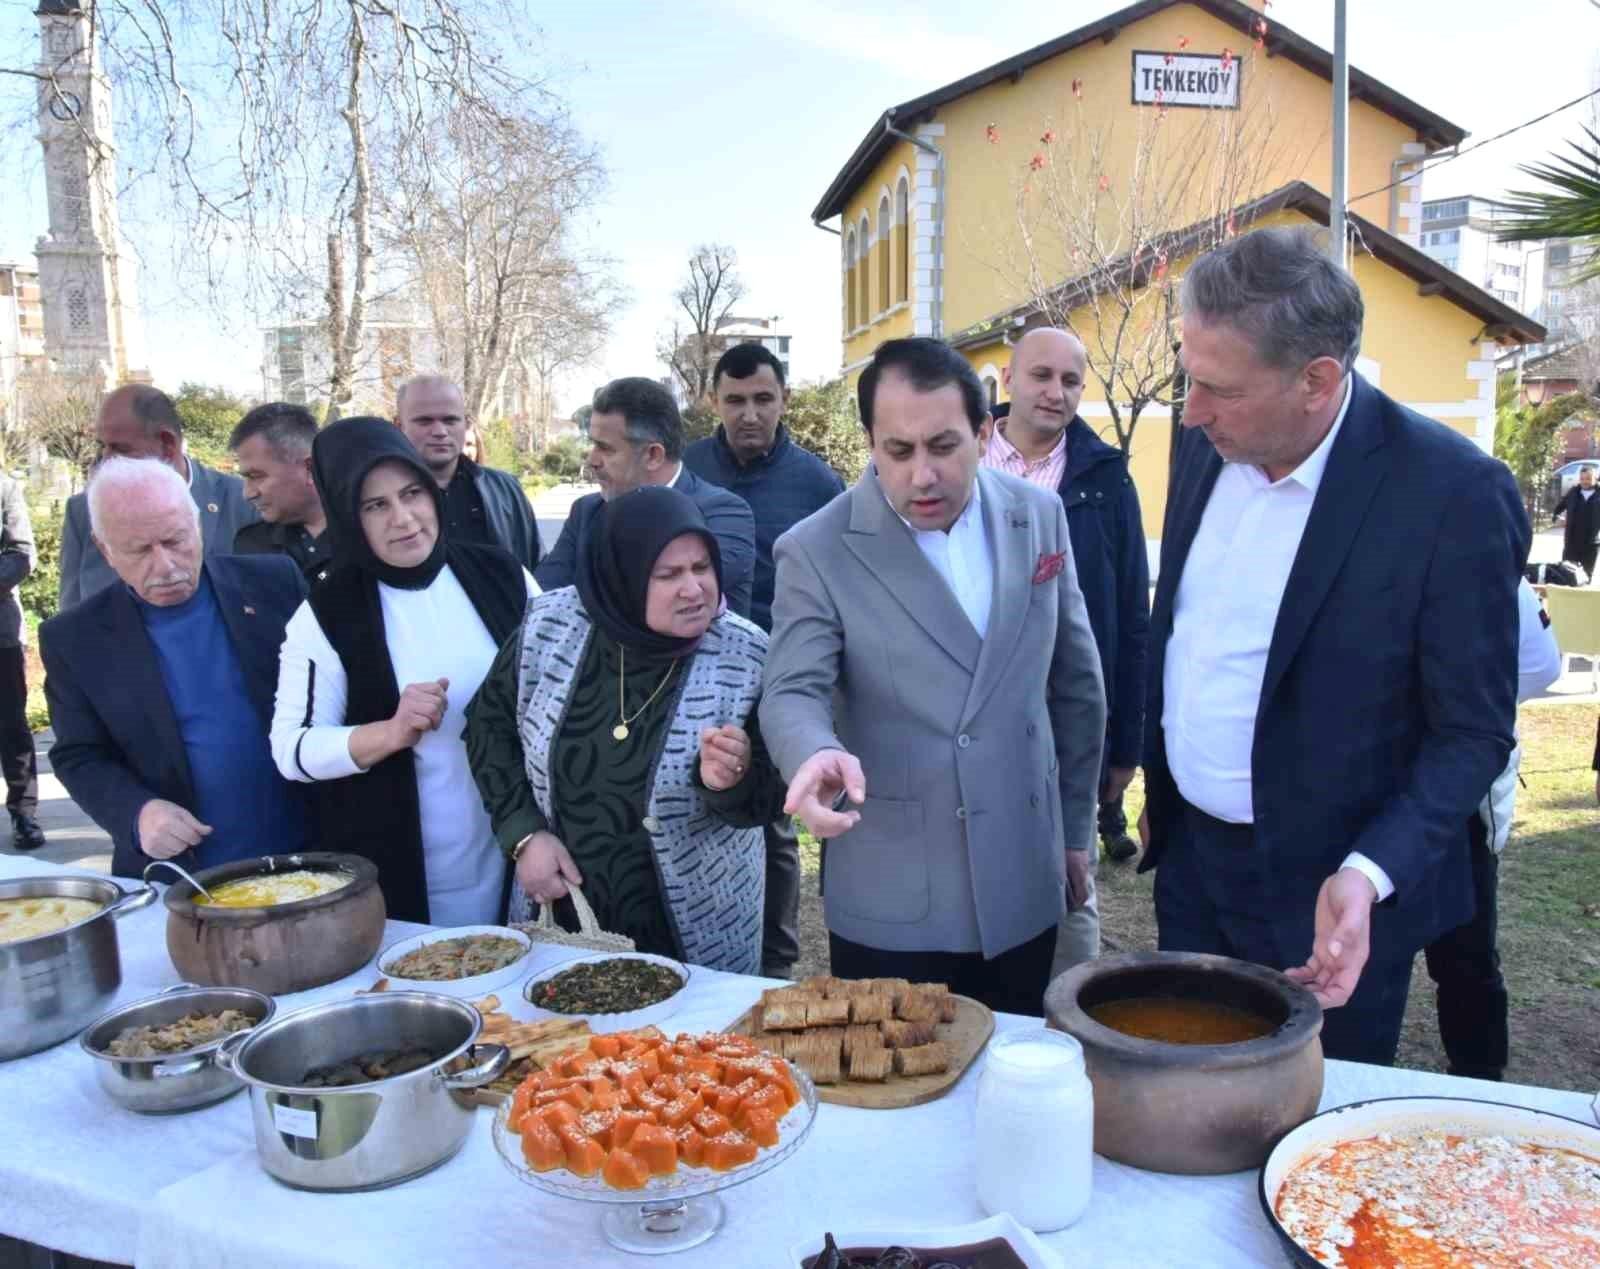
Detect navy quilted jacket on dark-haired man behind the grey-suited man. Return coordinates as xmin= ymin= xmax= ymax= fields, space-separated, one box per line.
xmin=683 ymin=424 xmax=845 ymax=632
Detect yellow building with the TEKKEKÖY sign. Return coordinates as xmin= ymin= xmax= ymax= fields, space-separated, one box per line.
xmin=813 ymin=0 xmax=1544 ymax=536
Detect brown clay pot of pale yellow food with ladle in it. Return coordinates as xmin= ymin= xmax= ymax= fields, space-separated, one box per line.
xmin=165 ymin=851 xmax=387 ymax=995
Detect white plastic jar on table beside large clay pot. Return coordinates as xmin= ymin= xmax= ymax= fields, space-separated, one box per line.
xmin=976 ymin=1027 xmax=1094 ymax=1231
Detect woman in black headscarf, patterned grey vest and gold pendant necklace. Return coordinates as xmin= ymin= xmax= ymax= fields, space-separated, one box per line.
xmin=467 ymin=485 xmax=784 ymax=973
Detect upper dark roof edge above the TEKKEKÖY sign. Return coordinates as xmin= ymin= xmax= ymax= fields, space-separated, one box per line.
xmin=811 ymin=0 xmax=1467 ymax=222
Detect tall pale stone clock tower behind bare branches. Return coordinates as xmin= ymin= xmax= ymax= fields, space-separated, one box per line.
xmin=34 ymin=0 xmax=150 ymax=387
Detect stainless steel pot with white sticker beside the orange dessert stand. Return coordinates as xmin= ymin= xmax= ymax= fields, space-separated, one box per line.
xmin=216 ymin=992 xmax=510 ymax=1191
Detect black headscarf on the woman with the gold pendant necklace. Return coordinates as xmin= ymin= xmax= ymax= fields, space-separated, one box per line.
xmin=576 ymin=485 xmax=722 ymax=656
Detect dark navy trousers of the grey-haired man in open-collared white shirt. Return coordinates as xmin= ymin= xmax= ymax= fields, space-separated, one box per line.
xmin=1155 ymin=807 xmax=1413 ymax=1066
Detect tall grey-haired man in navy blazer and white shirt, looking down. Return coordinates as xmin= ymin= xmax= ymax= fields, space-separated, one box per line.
xmin=1141 ymin=229 xmax=1530 ymax=1063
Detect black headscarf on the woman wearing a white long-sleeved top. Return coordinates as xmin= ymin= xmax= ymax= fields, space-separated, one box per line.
xmin=310 ymin=414 xmax=446 ymax=590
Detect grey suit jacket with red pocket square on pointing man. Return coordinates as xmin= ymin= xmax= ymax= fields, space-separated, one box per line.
xmin=760 ymin=469 xmax=1106 ymax=957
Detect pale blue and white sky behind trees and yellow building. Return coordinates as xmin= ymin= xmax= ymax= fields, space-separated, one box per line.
xmin=0 ymin=0 xmax=1600 ymax=410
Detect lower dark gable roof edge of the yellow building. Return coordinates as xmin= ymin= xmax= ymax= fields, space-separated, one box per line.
xmin=950 ymin=181 xmax=1546 ymax=352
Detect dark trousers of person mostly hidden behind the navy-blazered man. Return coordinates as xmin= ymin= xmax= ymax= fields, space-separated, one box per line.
xmin=1427 ymin=816 xmax=1510 ymax=1080
